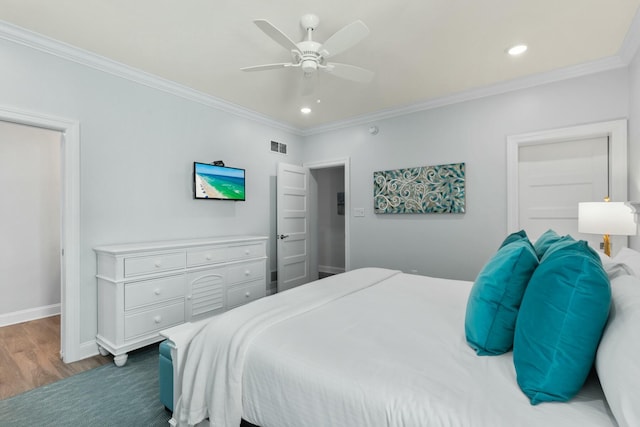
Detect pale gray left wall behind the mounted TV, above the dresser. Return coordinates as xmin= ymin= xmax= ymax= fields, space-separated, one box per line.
xmin=0 ymin=36 xmax=302 ymax=342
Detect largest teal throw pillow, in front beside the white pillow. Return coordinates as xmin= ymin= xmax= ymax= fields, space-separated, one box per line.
xmin=513 ymin=239 xmax=611 ymax=405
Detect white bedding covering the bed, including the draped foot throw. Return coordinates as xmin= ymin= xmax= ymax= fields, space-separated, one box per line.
xmin=177 ymin=269 xmax=616 ymax=427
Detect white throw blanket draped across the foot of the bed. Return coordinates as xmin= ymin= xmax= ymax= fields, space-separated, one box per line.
xmin=174 ymin=268 xmax=399 ymax=427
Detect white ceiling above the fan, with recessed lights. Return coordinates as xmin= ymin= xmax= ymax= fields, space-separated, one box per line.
xmin=0 ymin=0 xmax=640 ymax=130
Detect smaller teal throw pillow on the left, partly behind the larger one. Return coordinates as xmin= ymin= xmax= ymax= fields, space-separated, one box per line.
xmin=465 ymin=238 xmax=538 ymax=356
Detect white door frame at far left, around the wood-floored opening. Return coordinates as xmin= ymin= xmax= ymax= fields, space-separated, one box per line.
xmin=0 ymin=106 xmax=80 ymax=363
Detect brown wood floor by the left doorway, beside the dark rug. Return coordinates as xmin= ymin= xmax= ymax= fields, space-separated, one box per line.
xmin=0 ymin=316 xmax=111 ymax=399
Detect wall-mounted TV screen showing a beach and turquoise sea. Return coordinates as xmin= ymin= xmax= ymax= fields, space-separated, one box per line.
xmin=193 ymin=162 xmax=245 ymax=201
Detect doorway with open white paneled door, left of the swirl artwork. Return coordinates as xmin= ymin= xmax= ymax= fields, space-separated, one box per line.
xmin=275 ymin=158 xmax=350 ymax=292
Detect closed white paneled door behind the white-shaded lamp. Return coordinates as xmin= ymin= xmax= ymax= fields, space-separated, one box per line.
xmin=518 ymin=137 xmax=626 ymax=249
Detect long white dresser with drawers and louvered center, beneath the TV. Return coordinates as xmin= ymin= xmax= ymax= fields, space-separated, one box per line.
xmin=94 ymin=236 xmax=267 ymax=366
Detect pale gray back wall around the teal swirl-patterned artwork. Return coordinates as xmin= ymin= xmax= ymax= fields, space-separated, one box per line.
xmin=304 ymin=69 xmax=637 ymax=280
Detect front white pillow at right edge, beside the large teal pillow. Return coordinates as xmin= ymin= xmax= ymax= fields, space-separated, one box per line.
xmin=596 ymin=275 xmax=640 ymax=427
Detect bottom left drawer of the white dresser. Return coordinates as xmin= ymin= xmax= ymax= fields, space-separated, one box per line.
xmin=124 ymin=301 xmax=184 ymax=340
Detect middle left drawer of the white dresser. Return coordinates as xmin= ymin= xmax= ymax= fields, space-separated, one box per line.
xmin=124 ymin=274 xmax=185 ymax=310
